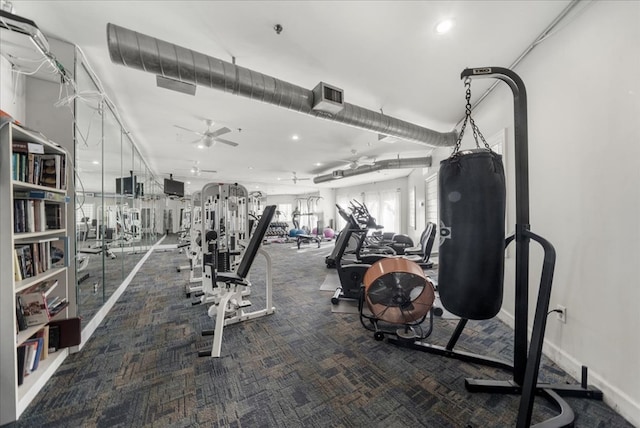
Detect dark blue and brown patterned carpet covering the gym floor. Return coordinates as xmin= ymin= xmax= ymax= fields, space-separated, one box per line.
xmin=7 ymin=244 xmax=631 ymax=428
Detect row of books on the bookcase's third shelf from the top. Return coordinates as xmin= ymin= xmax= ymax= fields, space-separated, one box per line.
xmin=13 ymin=236 xmax=69 ymax=281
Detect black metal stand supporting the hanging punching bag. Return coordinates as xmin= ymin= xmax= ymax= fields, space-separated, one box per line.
xmin=388 ymin=67 xmax=603 ymax=428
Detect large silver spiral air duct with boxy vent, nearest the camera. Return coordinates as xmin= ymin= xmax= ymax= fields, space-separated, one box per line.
xmin=107 ymin=23 xmax=457 ymax=147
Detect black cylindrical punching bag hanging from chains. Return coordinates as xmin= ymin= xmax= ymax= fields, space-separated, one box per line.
xmin=438 ymin=149 xmax=506 ymax=320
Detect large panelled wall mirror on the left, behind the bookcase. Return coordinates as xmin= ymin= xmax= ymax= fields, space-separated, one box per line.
xmin=75 ymin=57 xmax=164 ymax=322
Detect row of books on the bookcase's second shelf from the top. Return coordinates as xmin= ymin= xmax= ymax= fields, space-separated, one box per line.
xmin=13 ymin=199 xmax=63 ymax=233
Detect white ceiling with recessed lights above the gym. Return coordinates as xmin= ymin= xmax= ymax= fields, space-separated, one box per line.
xmin=12 ymin=0 xmax=570 ymax=194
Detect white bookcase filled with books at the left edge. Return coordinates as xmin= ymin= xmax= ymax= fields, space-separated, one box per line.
xmin=0 ymin=123 xmax=77 ymax=425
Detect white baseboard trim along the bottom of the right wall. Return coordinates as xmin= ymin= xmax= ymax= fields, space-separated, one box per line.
xmin=498 ymin=309 xmax=640 ymax=427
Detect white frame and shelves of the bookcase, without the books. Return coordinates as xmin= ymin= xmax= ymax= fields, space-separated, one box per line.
xmin=0 ymin=123 xmax=77 ymax=425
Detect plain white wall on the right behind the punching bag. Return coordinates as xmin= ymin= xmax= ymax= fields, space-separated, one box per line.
xmin=434 ymin=1 xmax=640 ymax=426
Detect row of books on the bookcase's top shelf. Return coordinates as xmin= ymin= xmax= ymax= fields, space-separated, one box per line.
xmin=11 ymin=141 xmax=67 ymax=189
